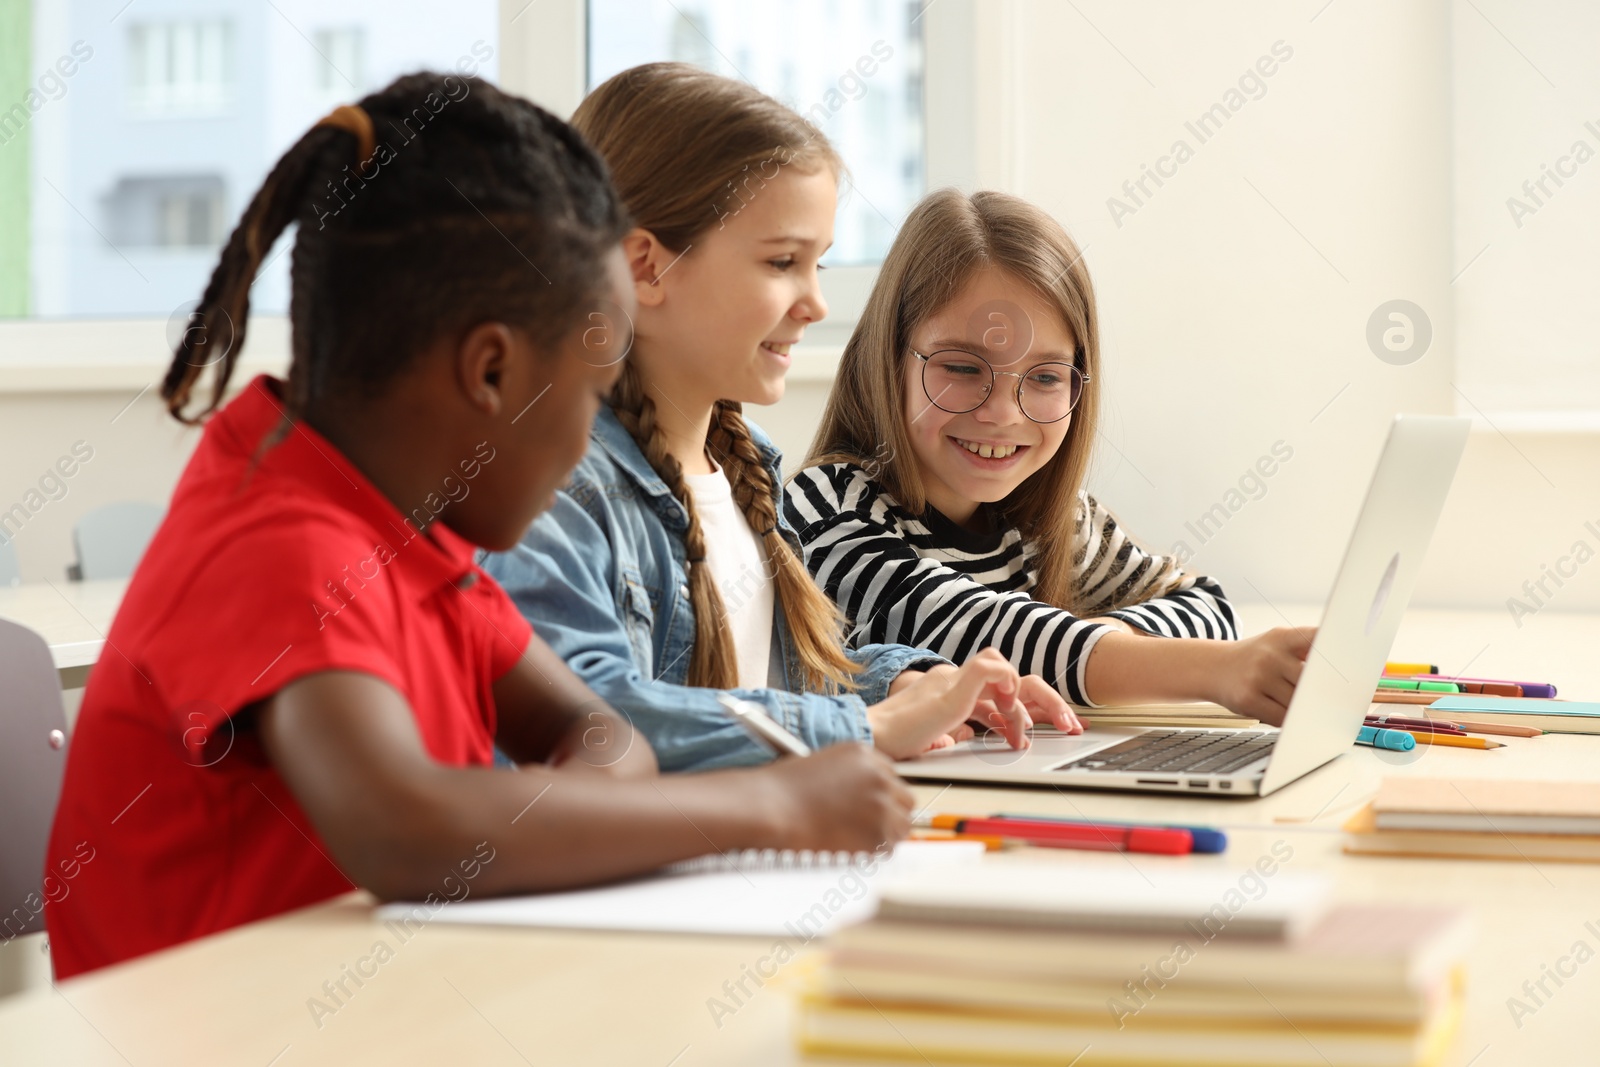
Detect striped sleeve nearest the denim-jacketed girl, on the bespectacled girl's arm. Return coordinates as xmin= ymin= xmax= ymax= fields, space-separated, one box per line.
xmin=784 ymin=464 xmax=1110 ymax=707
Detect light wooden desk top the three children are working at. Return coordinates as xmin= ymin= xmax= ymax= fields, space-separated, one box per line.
xmin=0 ymin=611 xmax=1600 ymax=1067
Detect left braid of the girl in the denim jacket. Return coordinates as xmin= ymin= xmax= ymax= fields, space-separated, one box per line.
xmin=611 ymin=363 xmax=739 ymax=689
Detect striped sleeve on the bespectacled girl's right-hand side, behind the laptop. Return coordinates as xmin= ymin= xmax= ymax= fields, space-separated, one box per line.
xmin=1077 ymin=493 xmax=1238 ymax=641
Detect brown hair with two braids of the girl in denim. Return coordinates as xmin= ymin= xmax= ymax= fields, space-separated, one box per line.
xmin=573 ymin=62 xmax=858 ymax=689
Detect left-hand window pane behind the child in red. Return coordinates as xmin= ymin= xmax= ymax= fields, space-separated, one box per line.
xmin=0 ymin=0 xmax=499 ymax=320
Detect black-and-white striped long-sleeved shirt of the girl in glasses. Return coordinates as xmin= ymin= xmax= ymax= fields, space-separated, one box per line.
xmin=784 ymin=464 xmax=1238 ymax=707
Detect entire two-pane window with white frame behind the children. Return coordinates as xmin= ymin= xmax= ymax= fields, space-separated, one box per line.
xmin=0 ymin=0 xmax=972 ymax=337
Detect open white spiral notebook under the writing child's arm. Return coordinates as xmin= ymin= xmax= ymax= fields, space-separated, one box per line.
xmin=374 ymin=841 xmax=984 ymax=941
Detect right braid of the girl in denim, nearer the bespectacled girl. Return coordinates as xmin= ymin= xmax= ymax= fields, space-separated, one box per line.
xmin=707 ymin=400 xmax=861 ymax=693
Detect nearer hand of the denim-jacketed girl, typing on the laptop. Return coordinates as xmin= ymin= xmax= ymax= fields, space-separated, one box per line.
xmin=867 ymin=648 xmax=1036 ymax=760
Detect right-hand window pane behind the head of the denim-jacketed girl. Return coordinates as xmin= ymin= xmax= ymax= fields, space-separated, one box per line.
xmin=589 ymin=0 xmax=923 ymax=266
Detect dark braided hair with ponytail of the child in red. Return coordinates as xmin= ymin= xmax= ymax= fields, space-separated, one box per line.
xmin=162 ymin=72 xmax=630 ymax=424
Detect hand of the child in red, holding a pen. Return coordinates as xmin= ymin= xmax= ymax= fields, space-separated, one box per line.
xmin=754 ymin=742 xmax=914 ymax=853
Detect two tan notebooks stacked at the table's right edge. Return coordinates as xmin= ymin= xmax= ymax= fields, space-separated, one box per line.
xmin=1344 ymin=777 xmax=1600 ymax=862
